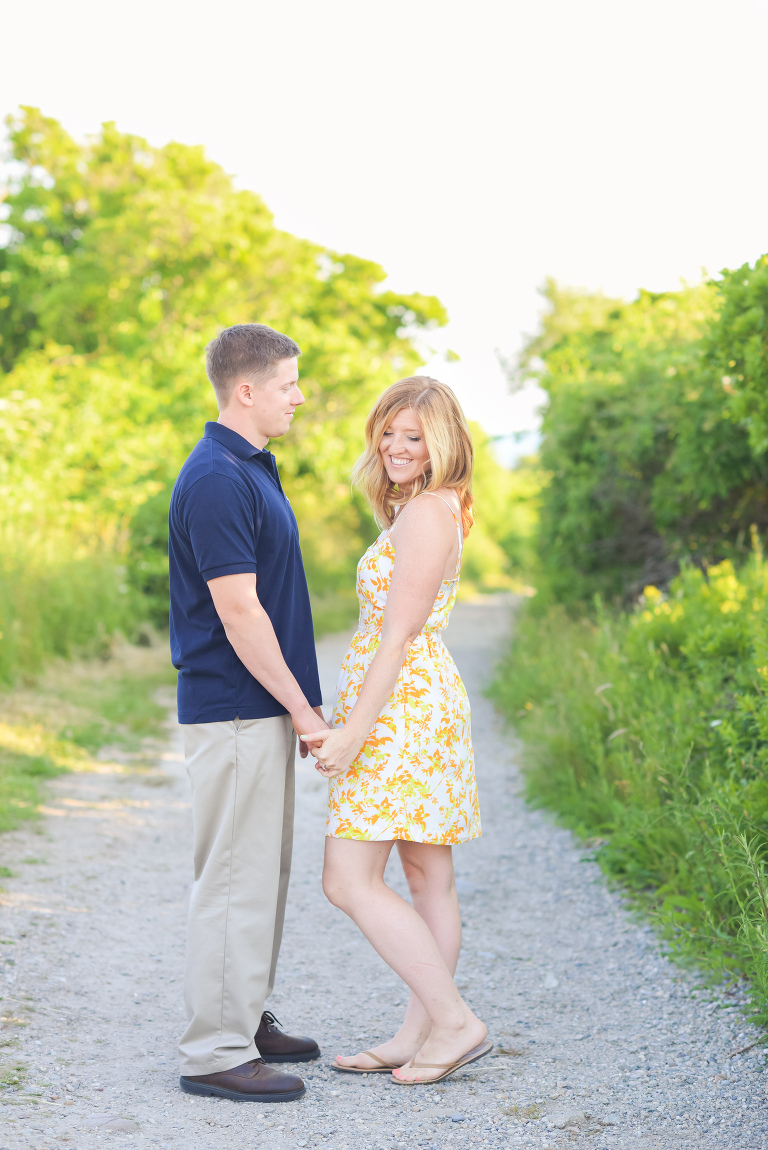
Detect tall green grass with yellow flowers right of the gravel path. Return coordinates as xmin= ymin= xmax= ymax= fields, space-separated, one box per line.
xmin=493 ymin=554 xmax=768 ymax=1021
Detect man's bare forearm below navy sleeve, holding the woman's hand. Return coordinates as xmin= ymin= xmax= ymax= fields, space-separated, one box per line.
xmin=208 ymin=573 xmax=324 ymax=758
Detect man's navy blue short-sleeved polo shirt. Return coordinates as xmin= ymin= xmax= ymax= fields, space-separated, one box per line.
xmin=168 ymin=423 xmax=322 ymax=723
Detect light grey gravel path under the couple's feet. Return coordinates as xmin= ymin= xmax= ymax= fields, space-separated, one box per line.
xmin=0 ymin=599 xmax=768 ymax=1150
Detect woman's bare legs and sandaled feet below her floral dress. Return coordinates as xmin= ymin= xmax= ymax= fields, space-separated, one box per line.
xmin=323 ymin=838 xmax=486 ymax=1076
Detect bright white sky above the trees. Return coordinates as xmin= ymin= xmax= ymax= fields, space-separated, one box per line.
xmin=0 ymin=0 xmax=768 ymax=460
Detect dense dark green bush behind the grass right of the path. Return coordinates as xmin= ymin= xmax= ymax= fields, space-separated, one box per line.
xmin=523 ymin=273 xmax=768 ymax=600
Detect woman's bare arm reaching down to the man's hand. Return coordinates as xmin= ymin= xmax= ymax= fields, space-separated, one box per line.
xmin=306 ymin=499 xmax=456 ymax=777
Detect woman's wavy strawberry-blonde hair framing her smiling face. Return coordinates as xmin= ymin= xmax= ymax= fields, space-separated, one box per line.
xmin=352 ymin=375 xmax=475 ymax=536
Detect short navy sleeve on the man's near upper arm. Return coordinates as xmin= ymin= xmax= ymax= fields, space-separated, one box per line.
xmin=182 ymin=473 xmax=261 ymax=582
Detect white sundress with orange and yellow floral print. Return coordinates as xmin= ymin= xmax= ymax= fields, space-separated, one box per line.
xmin=325 ymin=492 xmax=481 ymax=844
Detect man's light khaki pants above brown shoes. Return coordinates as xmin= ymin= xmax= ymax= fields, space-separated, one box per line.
xmin=179 ymin=715 xmax=295 ymax=1074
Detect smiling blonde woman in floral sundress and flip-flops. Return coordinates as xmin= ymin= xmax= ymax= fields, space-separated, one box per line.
xmin=304 ymin=376 xmax=492 ymax=1086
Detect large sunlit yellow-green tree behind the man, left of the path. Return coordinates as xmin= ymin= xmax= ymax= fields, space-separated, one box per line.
xmin=0 ymin=108 xmax=445 ymax=625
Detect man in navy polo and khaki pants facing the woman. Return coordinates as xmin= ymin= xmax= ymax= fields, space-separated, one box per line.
xmin=169 ymin=323 xmax=322 ymax=1102
